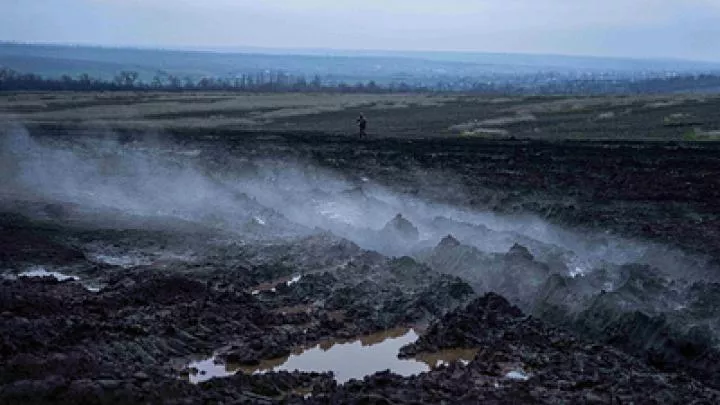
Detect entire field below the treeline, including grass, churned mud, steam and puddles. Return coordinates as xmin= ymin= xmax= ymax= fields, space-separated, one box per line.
xmin=0 ymin=94 xmax=720 ymax=404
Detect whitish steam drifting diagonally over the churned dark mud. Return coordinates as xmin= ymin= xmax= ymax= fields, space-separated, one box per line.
xmin=0 ymin=124 xmax=716 ymax=286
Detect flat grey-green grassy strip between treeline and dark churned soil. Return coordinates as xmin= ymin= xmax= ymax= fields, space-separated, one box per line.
xmin=0 ymin=92 xmax=720 ymax=141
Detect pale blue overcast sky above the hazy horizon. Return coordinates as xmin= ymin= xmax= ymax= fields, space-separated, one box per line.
xmin=5 ymin=0 xmax=720 ymax=61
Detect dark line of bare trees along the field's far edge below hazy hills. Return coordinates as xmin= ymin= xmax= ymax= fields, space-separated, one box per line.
xmin=0 ymin=68 xmax=720 ymax=95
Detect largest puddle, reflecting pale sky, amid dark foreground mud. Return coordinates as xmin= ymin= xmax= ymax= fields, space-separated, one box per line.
xmin=188 ymin=329 xmax=477 ymax=384
